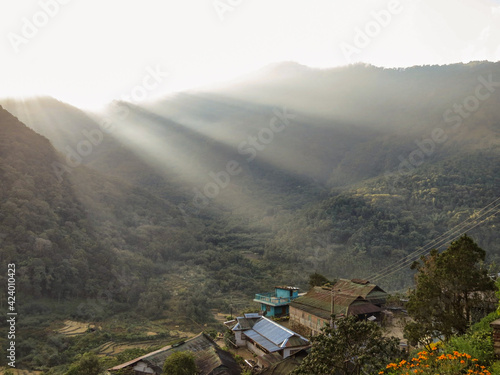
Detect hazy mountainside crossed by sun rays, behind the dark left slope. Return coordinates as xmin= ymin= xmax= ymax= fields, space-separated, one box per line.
xmin=3 ymin=62 xmax=500 ymax=299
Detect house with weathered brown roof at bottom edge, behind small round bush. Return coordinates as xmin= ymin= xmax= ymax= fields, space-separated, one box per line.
xmin=108 ymin=333 xmax=241 ymax=375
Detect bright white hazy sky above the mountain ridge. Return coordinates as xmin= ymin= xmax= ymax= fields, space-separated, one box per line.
xmin=0 ymin=0 xmax=500 ymax=107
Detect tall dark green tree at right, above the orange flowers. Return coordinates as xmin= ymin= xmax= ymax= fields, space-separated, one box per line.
xmin=405 ymin=235 xmax=496 ymax=344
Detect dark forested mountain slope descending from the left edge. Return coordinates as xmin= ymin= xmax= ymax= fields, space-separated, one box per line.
xmin=0 ymin=104 xmax=113 ymax=297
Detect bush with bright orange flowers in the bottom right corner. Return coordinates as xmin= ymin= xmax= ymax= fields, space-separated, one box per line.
xmin=379 ymin=347 xmax=491 ymax=375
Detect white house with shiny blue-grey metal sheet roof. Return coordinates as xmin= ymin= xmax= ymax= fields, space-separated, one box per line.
xmin=228 ymin=313 xmax=310 ymax=358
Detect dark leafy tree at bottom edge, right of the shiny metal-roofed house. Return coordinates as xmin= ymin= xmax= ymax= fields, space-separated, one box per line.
xmin=292 ymin=316 xmax=403 ymax=375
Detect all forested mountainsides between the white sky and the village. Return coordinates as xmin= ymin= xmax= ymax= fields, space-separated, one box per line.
xmin=0 ymin=63 xmax=500 ymax=374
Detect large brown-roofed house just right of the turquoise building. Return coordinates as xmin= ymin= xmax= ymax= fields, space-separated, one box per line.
xmin=290 ymin=279 xmax=387 ymax=336
